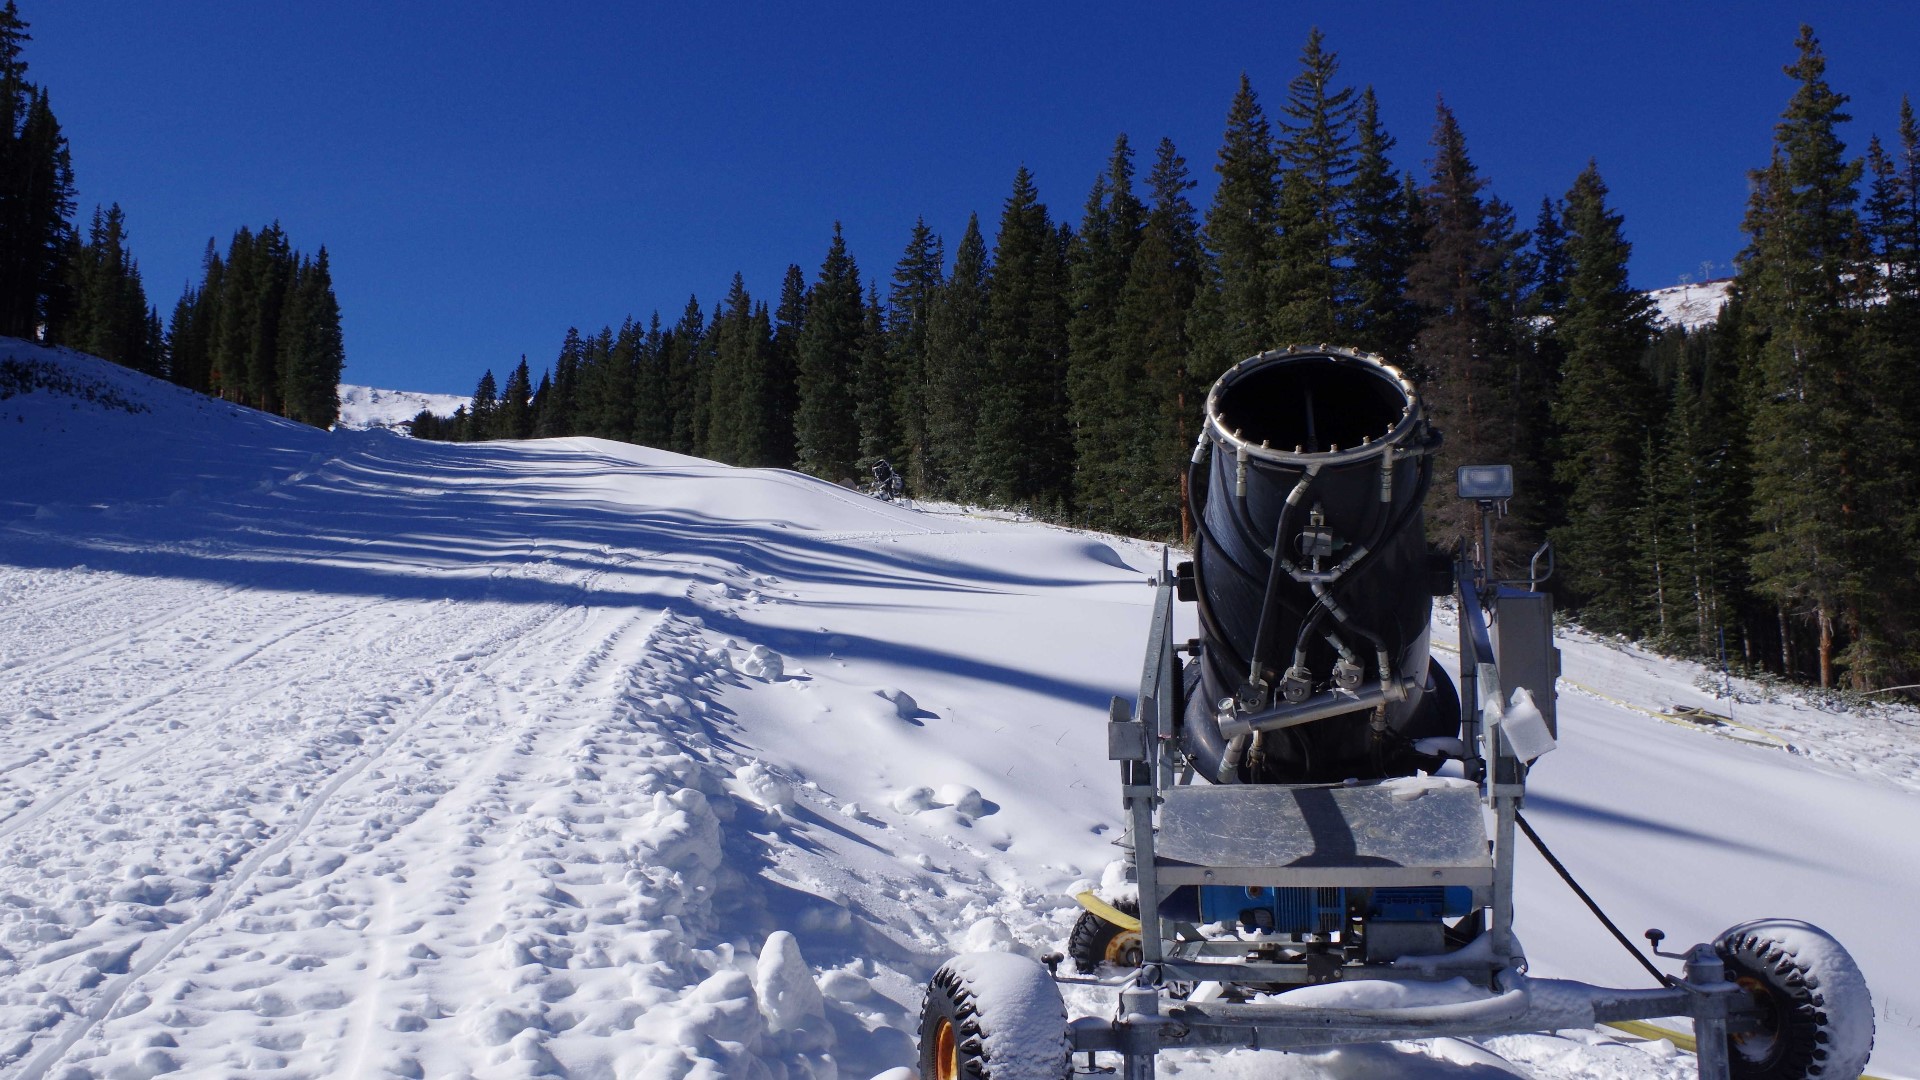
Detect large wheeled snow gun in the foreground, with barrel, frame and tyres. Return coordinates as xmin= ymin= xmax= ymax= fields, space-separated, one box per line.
xmin=920 ymin=346 xmax=1874 ymax=1080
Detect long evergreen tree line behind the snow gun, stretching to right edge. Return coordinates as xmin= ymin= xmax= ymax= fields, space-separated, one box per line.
xmin=424 ymin=27 xmax=1920 ymax=690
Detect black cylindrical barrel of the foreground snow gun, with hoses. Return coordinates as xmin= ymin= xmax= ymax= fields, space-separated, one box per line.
xmin=1185 ymin=346 xmax=1459 ymax=782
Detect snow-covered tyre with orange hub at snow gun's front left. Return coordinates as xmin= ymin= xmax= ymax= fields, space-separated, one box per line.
xmin=920 ymin=953 xmax=1071 ymax=1080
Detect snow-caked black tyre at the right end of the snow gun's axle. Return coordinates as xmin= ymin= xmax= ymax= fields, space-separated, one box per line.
xmin=1715 ymin=919 xmax=1874 ymax=1080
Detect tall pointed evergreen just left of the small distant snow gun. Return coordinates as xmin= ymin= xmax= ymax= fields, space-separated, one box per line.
xmin=793 ymin=221 xmax=866 ymax=480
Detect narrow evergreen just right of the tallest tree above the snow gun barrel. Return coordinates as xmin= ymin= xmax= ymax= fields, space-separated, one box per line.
xmin=1334 ymin=86 xmax=1419 ymax=355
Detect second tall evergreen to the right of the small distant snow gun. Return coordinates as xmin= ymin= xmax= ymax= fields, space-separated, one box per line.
xmin=925 ymin=215 xmax=991 ymax=500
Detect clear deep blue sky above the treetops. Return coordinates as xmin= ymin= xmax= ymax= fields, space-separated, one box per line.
xmin=19 ymin=0 xmax=1920 ymax=394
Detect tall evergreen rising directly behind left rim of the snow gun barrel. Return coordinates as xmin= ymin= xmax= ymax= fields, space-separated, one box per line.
xmin=1190 ymin=73 xmax=1279 ymax=380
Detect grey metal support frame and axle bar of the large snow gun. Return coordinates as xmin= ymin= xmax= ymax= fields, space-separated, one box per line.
xmin=1069 ymin=549 xmax=1759 ymax=1080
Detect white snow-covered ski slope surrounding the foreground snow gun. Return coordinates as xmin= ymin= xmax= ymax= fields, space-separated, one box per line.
xmin=0 ymin=342 xmax=1920 ymax=1080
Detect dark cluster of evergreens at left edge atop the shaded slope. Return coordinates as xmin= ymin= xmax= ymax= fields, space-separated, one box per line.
xmin=0 ymin=0 xmax=346 ymax=427
